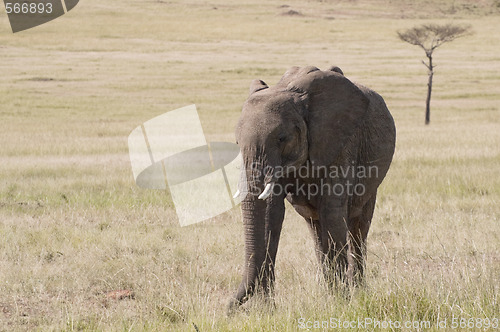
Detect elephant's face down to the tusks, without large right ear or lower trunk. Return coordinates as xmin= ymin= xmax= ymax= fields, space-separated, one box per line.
xmin=236 ymin=80 xmax=308 ymax=199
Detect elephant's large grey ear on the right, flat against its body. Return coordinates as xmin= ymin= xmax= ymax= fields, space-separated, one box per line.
xmin=287 ymin=70 xmax=369 ymax=166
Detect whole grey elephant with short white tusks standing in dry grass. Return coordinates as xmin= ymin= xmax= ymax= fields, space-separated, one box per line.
xmin=229 ymin=67 xmax=396 ymax=312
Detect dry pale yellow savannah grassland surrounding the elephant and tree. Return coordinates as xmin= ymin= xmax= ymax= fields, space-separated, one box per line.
xmin=0 ymin=0 xmax=500 ymax=331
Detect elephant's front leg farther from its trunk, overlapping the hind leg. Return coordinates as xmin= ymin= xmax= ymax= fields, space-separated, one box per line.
xmin=320 ymin=196 xmax=349 ymax=286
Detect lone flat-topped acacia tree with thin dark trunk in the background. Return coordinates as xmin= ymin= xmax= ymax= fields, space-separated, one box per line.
xmin=398 ymin=23 xmax=471 ymax=124
